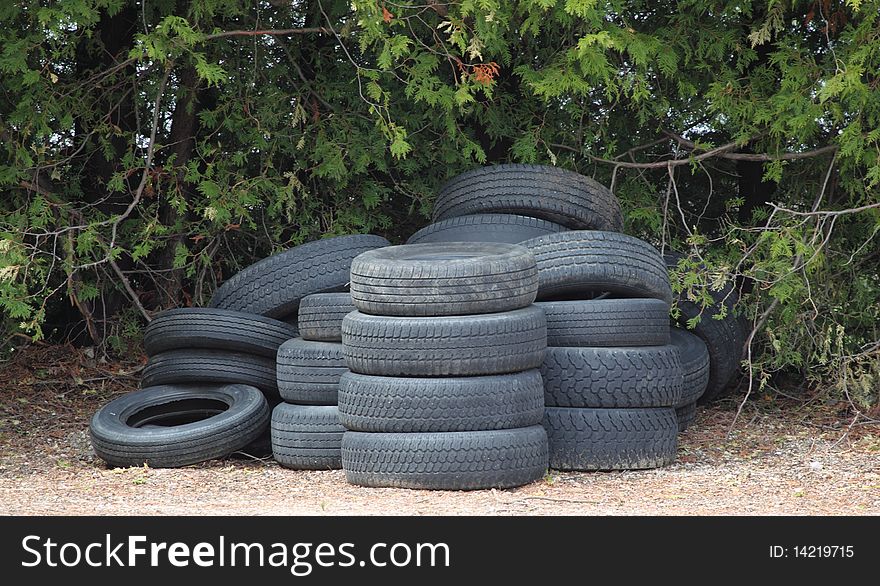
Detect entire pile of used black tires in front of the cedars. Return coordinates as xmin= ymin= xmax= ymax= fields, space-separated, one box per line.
xmin=91 ymin=165 xmax=745 ymax=489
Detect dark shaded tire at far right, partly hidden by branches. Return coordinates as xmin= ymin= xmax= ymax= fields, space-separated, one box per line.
xmin=663 ymin=252 xmax=746 ymax=405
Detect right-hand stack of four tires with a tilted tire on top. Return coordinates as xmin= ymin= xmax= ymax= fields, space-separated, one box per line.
xmin=522 ymin=230 xmax=682 ymax=470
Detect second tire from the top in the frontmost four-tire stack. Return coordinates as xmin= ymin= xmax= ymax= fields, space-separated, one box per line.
xmin=342 ymin=307 xmax=547 ymax=377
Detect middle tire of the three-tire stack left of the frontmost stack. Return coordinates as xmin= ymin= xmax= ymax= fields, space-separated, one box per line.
xmin=278 ymin=338 xmax=348 ymax=405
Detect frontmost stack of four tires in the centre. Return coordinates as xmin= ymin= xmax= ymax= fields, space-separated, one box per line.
xmin=339 ymin=242 xmax=547 ymax=490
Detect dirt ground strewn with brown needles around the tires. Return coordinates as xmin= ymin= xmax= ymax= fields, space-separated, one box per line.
xmin=0 ymin=347 xmax=880 ymax=515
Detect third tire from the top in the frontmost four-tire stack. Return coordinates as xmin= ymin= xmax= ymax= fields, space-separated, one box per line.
xmin=339 ymin=370 xmax=544 ymax=433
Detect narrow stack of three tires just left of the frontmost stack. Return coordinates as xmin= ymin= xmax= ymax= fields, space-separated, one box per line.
xmin=271 ymin=293 xmax=354 ymax=470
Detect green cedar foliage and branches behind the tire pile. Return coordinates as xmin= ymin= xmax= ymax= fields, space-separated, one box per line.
xmin=0 ymin=0 xmax=880 ymax=407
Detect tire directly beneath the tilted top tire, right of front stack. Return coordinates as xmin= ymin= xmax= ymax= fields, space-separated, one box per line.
xmin=535 ymin=299 xmax=669 ymax=348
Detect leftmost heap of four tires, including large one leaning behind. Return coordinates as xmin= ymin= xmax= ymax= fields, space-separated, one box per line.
xmin=90 ymin=235 xmax=389 ymax=467
